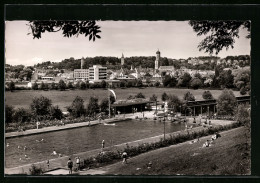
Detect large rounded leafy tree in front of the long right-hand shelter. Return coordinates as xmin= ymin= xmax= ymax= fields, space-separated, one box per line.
xmin=217 ymin=89 xmax=237 ymax=115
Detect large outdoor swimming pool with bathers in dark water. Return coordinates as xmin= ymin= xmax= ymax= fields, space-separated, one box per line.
xmin=5 ymin=120 xmax=184 ymax=168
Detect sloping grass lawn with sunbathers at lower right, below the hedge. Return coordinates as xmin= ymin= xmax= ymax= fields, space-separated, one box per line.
xmin=100 ymin=127 xmax=251 ymax=175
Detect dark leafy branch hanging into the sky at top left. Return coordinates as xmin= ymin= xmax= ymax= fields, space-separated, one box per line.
xmin=27 ymin=20 xmax=101 ymax=41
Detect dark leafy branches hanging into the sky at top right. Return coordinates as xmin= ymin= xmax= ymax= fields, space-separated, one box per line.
xmin=189 ymin=21 xmax=251 ymax=54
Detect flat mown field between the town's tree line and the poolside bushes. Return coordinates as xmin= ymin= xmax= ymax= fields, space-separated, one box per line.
xmin=5 ymin=87 xmax=240 ymax=111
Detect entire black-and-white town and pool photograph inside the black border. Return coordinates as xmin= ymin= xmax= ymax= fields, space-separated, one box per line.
xmin=4 ymin=19 xmax=251 ymax=176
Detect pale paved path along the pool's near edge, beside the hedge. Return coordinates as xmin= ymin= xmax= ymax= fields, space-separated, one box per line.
xmin=5 ymin=120 xmax=233 ymax=174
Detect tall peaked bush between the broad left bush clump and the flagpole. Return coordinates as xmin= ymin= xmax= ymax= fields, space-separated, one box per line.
xmin=67 ymin=96 xmax=86 ymax=118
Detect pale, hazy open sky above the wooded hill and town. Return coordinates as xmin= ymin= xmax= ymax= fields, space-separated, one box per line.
xmin=5 ymin=21 xmax=250 ymax=66
